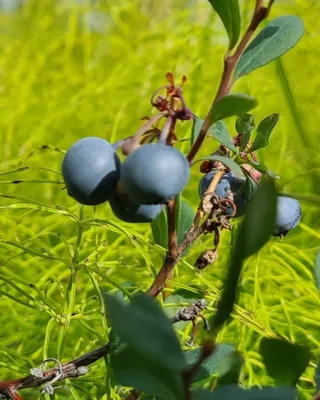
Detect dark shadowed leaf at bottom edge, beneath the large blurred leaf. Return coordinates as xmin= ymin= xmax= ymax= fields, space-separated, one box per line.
xmin=111 ymin=346 xmax=183 ymax=400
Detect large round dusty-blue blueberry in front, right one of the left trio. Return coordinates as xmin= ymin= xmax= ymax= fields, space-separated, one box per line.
xmin=120 ymin=143 xmax=190 ymax=204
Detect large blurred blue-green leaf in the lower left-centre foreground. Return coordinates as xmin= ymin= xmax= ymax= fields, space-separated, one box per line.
xmin=105 ymin=294 xmax=185 ymax=371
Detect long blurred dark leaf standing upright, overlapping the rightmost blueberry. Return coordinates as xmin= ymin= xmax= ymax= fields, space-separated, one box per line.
xmin=212 ymin=181 xmax=277 ymax=332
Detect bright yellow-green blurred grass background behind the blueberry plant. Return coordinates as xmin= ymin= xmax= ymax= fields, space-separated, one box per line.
xmin=0 ymin=0 xmax=320 ymax=399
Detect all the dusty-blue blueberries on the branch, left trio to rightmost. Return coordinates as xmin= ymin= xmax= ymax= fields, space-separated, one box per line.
xmin=62 ymin=137 xmax=301 ymax=236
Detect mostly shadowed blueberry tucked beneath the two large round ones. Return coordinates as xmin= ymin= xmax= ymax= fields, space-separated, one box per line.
xmin=109 ymin=193 xmax=162 ymax=223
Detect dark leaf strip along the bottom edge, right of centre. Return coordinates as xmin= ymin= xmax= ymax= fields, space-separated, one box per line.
xmin=191 ymin=385 xmax=297 ymax=400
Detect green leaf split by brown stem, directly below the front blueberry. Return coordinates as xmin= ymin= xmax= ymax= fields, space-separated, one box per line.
xmin=151 ymin=195 xmax=195 ymax=255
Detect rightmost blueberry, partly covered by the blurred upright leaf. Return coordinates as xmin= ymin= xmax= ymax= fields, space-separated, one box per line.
xmin=273 ymin=196 xmax=301 ymax=236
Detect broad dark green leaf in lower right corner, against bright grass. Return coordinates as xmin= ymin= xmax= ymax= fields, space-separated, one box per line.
xmin=260 ymin=338 xmax=311 ymax=386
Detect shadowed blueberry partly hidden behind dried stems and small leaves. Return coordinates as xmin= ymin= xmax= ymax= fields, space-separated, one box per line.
xmin=198 ymin=171 xmax=247 ymax=217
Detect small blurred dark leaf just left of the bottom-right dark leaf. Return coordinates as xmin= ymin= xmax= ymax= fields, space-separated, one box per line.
xmin=217 ymin=351 xmax=244 ymax=386
